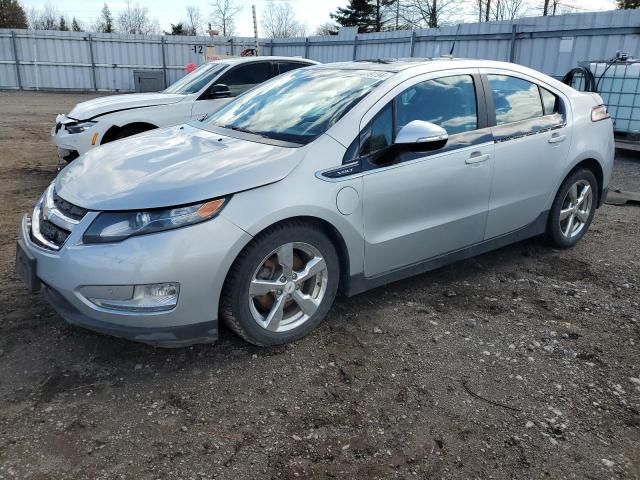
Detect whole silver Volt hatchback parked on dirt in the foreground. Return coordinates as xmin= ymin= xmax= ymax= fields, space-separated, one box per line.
xmin=16 ymin=59 xmax=614 ymax=346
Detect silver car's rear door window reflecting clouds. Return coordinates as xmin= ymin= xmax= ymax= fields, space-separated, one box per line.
xmin=487 ymin=75 xmax=543 ymax=125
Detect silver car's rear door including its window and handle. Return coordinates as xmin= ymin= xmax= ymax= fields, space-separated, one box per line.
xmin=482 ymin=69 xmax=571 ymax=239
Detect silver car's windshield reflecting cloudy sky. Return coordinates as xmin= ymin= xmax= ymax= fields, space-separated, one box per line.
xmin=206 ymin=67 xmax=391 ymax=144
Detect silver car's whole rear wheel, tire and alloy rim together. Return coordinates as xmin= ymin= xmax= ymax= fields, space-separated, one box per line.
xmin=547 ymin=168 xmax=599 ymax=248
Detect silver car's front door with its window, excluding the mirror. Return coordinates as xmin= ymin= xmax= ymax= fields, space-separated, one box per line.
xmin=360 ymin=72 xmax=494 ymax=277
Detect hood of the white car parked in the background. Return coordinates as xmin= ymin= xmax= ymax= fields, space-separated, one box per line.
xmin=68 ymin=93 xmax=186 ymax=120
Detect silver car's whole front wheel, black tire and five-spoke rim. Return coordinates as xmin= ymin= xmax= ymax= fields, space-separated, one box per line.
xmin=220 ymin=221 xmax=340 ymax=346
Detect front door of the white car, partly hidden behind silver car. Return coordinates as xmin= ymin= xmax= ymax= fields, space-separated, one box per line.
xmin=191 ymin=61 xmax=273 ymax=119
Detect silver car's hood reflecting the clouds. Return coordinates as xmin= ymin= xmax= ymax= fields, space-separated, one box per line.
xmin=55 ymin=125 xmax=304 ymax=210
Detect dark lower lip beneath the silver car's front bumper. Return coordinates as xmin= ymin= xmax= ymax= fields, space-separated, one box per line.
xmin=44 ymin=285 xmax=218 ymax=348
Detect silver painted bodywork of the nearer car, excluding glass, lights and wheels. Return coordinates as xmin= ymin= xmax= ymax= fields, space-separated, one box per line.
xmin=21 ymin=60 xmax=613 ymax=341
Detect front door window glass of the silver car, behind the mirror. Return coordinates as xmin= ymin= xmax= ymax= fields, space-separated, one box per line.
xmin=396 ymin=75 xmax=478 ymax=135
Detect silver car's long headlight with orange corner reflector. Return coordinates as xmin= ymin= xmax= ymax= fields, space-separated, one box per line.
xmin=83 ymin=198 xmax=226 ymax=243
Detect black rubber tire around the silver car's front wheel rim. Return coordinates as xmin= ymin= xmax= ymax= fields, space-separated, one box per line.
xmin=220 ymin=220 xmax=340 ymax=346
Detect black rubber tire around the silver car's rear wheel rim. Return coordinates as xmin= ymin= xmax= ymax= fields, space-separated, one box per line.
xmin=547 ymin=168 xmax=599 ymax=248
